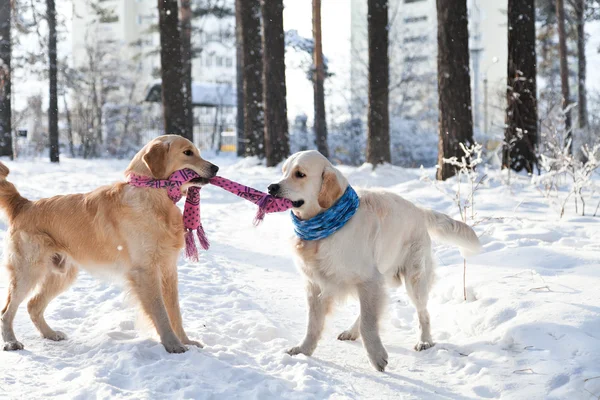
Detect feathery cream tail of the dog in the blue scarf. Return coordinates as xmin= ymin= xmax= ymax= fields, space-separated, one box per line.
xmin=423 ymin=210 xmax=481 ymax=256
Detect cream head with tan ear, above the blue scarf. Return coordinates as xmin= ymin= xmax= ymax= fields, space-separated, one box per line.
xmin=269 ymin=150 xmax=348 ymax=220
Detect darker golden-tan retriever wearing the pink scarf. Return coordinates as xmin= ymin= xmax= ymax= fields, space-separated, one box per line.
xmin=0 ymin=135 xmax=219 ymax=353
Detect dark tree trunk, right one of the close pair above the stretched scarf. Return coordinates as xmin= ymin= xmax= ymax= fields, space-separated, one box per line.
xmin=260 ymin=0 xmax=290 ymax=167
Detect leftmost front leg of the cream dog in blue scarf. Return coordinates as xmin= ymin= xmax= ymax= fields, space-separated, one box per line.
xmin=287 ymin=282 xmax=332 ymax=356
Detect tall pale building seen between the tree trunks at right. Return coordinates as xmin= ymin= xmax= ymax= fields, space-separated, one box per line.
xmin=350 ymin=0 xmax=507 ymax=141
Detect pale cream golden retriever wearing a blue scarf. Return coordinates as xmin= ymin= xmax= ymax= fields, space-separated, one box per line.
xmin=269 ymin=151 xmax=480 ymax=371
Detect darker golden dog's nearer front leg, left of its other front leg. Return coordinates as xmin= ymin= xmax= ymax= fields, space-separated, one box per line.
xmin=128 ymin=266 xmax=187 ymax=353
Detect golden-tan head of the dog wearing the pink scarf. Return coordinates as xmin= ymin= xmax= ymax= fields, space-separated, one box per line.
xmin=126 ymin=135 xmax=219 ymax=186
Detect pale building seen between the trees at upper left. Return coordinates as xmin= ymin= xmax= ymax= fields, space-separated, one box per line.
xmin=71 ymin=0 xmax=236 ymax=148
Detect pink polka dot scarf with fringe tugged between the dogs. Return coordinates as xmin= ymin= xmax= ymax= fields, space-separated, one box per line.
xmin=127 ymin=169 xmax=292 ymax=261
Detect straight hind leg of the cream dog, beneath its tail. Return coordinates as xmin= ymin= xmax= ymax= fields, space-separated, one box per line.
xmin=405 ymin=251 xmax=435 ymax=351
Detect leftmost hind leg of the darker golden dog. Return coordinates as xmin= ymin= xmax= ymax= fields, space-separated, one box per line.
xmin=0 ymin=263 xmax=39 ymax=351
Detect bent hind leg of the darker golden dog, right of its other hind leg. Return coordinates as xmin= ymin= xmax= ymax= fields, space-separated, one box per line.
xmin=27 ymin=263 xmax=78 ymax=341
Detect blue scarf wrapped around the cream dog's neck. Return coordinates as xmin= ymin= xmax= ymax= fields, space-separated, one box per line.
xmin=291 ymin=185 xmax=360 ymax=240
